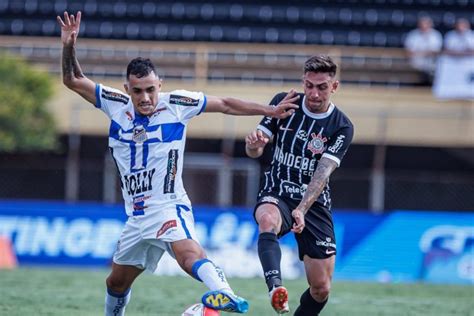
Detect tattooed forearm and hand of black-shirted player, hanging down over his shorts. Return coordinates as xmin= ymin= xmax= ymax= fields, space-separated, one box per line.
xmin=291 ymin=157 xmax=337 ymax=234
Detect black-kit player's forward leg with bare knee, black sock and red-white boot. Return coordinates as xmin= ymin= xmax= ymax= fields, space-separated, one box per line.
xmin=255 ymin=201 xmax=289 ymax=314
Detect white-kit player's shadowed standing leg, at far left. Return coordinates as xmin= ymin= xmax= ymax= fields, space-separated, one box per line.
xmin=105 ymin=263 xmax=143 ymax=316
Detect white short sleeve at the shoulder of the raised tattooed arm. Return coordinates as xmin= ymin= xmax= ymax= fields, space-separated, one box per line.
xmin=95 ymin=84 xmax=130 ymax=118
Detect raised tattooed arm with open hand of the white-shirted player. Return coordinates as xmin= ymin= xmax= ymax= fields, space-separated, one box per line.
xmin=56 ymin=12 xmax=96 ymax=104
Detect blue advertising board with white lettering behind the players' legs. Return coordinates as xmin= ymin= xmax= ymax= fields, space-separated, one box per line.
xmin=0 ymin=201 xmax=474 ymax=284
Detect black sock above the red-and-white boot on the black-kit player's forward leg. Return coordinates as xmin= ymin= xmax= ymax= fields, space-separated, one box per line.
xmin=258 ymin=233 xmax=281 ymax=290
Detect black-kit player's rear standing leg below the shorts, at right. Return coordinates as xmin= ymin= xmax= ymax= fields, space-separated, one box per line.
xmin=294 ymin=255 xmax=336 ymax=316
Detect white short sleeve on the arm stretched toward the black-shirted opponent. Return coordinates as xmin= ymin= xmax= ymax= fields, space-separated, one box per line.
xmin=168 ymin=90 xmax=207 ymax=121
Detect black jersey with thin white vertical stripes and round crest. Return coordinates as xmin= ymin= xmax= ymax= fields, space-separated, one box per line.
xmin=257 ymin=93 xmax=354 ymax=208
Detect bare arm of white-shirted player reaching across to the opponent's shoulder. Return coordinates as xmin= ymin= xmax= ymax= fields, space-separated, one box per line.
xmin=206 ymin=90 xmax=299 ymax=119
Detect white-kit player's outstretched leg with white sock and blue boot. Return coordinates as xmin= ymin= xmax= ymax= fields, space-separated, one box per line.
xmin=171 ymin=239 xmax=248 ymax=313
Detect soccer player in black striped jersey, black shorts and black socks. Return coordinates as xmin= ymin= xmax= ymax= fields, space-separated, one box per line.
xmin=245 ymin=56 xmax=353 ymax=316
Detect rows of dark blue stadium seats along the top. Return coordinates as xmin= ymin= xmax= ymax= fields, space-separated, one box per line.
xmin=0 ymin=0 xmax=474 ymax=47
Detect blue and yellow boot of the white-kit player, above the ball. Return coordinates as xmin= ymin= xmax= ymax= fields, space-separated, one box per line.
xmin=202 ymin=291 xmax=249 ymax=314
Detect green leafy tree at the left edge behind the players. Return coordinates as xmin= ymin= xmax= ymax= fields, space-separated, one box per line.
xmin=0 ymin=52 xmax=57 ymax=152
